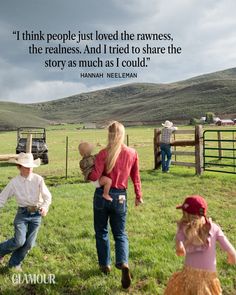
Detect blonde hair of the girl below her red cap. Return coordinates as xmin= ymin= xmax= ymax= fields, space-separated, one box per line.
xmin=178 ymin=211 xmax=210 ymax=246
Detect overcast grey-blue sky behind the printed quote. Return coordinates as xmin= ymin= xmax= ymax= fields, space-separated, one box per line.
xmin=0 ymin=0 xmax=236 ymax=103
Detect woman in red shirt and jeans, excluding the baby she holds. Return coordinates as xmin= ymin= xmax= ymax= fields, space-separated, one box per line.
xmin=89 ymin=121 xmax=143 ymax=288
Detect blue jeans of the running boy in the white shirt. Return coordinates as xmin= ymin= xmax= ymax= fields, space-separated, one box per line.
xmin=0 ymin=207 xmax=42 ymax=267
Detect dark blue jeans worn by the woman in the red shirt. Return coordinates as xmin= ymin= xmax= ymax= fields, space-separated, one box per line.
xmin=93 ymin=188 xmax=129 ymax=266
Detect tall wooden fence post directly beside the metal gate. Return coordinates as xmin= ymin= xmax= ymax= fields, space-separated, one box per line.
xmin=195 ymin=125 xmax=203 ymax=175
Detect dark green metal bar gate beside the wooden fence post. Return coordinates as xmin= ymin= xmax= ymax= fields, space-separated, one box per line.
xmin=203 ymin=129 xmax=236 ymax=174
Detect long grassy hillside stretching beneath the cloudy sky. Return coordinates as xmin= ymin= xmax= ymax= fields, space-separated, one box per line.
xmin=0 ymin=68 xmax=236 ymax=130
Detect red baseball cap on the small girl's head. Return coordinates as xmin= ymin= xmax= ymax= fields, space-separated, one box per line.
xmin=176 ymin=195 xmax=207 ymax=217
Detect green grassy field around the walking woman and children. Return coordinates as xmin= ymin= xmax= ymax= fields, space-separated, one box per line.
xmin=0 ymin=125 xmax=236 ymax=295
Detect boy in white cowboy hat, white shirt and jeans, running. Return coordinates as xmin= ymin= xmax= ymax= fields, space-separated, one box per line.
xmin=0 ymin=153 xmax=52 ymax=271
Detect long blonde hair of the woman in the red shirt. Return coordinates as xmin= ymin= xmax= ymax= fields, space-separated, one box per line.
xmin=106 ymin=121 xmax=125 ymax=173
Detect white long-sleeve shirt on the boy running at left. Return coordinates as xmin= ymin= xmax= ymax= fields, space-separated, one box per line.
xmin=0 ymin=173 xmax=52 ymax=212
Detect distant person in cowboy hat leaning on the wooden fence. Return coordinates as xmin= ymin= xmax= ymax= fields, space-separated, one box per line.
xmin=161 ymin=120 xmax=178 ymax=173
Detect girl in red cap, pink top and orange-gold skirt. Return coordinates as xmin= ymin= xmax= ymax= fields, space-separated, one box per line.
xmin=164 ymin=196 xmax=236 ymax=295
